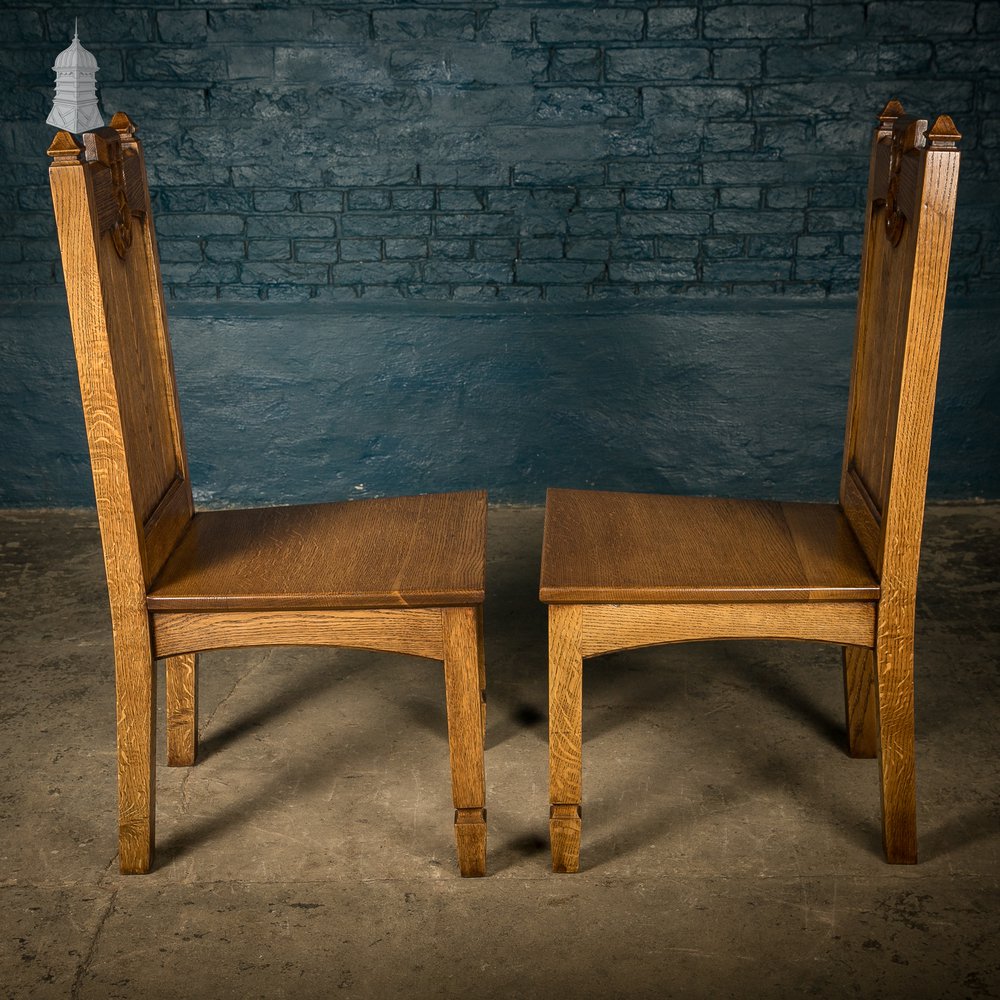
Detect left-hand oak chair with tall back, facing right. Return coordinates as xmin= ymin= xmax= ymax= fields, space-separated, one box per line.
xmin=48 ymin=114 xmax=486 ymax=875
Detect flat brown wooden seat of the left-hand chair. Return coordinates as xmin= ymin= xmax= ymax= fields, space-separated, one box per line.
xmin=148 ymin=492 xmax=486 ymax=611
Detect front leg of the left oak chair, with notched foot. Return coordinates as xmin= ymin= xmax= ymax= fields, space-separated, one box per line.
xmin=442 ymin=607 xmax=486 ymax=877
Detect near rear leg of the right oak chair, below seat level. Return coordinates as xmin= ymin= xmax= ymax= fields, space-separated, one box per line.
xmin=875 ymin=627 xmax=917 ymax=865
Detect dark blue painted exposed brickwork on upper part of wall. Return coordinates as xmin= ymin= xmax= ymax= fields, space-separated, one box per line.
xmin=0 ymin=0 xmax=1000 ymax=302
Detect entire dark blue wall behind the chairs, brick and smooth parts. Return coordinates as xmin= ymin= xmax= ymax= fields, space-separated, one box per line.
xmin=0 ymin=0 xmax=1000 ymax=505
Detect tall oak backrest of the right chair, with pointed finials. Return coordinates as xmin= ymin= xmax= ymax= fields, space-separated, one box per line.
xmin=840 ymin=101 xmax=961 ymax=590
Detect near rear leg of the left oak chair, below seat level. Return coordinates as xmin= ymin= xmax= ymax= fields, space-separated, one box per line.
xmin=115 ymin=622 xmax=156 ymax=875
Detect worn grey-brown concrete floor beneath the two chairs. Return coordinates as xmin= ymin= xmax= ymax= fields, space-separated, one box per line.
xmin=0 ymin=505 xmax=1000 ymax=1000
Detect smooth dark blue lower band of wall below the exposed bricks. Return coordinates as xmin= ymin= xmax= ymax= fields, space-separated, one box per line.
xmin=0 ymin=302 xmax=1000 ymax=505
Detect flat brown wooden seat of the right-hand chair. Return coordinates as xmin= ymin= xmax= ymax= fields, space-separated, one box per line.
xmin=541 ymin=490 xmax=879 ymax=604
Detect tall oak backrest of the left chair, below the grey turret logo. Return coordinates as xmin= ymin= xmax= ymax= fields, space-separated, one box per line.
xmin=49 ymin=114 xmax=193 ymax=604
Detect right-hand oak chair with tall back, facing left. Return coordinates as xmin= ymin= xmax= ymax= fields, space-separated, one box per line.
xmin=540 ymin=101 xmax=961 ymax=872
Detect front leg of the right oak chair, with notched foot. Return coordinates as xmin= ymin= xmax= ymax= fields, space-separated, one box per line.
xmin=549 ymin=605 xmax=583 ymax=872
